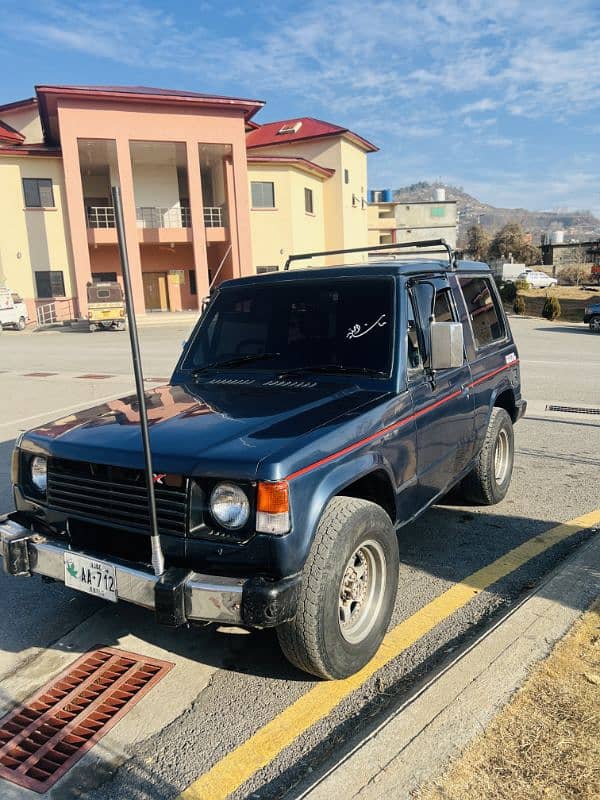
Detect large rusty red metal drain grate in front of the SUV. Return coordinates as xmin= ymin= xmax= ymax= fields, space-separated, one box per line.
xmin=0 ymin=647 xmax=173 ymax=792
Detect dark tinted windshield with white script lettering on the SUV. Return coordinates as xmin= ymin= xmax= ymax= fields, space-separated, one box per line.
xmin=183 ymin=277 xmax=394 ymax=377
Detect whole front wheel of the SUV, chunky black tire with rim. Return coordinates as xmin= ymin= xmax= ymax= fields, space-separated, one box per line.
xmin=277 ymin=497 xmax=398 ymax=679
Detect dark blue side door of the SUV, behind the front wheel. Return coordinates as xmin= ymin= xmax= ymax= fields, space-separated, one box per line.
xmin=407 ymin=277 xmax=475 ymax=506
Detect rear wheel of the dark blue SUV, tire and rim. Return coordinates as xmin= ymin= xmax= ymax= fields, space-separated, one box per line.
xmin=461 ymin=408 xmax=515 ymax=506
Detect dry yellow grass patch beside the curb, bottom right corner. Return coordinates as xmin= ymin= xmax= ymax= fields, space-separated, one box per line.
xmin=418 ymin=601 xmax=600 ymax=800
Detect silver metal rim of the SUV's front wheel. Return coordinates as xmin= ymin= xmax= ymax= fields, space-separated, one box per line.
xmin=338 ymin=539 xmax=386 ymax=644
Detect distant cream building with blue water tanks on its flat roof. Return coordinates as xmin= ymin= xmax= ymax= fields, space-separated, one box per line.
xmin=368 ymin=199 xmax=458 ymax=252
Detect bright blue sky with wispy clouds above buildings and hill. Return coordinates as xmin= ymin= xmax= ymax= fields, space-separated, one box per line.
xmin=0 ymin=0 xmax=600 ymax=215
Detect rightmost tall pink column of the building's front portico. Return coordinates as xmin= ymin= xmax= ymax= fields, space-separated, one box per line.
xmin=227 ymin=139 xmax=254 ymax=276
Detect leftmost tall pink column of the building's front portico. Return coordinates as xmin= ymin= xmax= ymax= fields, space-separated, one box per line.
xmin=61 ymin=136 xmax=92 ymax=317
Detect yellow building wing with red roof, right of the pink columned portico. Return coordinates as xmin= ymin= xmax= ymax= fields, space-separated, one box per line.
xmin=246 ymin=117 xmax=377 ymax=271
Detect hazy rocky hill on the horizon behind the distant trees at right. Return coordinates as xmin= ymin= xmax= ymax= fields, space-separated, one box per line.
xmin=394 ymin=181 xmax=600 ymax=244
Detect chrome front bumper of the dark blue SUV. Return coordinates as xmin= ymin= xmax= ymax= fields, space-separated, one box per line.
xmin=0 ymin=517 xmax=246 ymax=624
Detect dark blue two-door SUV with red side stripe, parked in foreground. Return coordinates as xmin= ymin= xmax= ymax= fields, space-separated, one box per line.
xmin=0 ymin=250 xmax=526 ymax=679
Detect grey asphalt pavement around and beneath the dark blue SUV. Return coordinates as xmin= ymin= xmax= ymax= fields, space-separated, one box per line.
xmin=0 ymin=319 xmax=600 ymax=800
